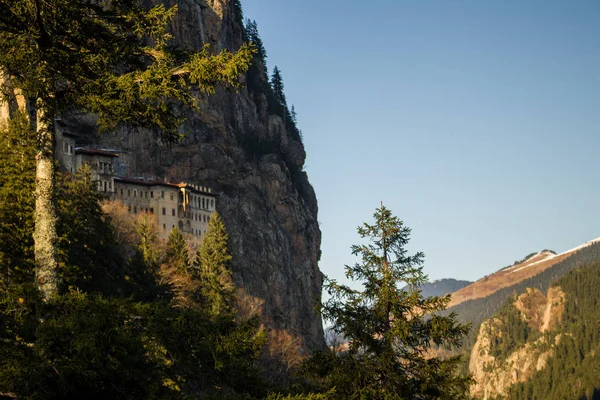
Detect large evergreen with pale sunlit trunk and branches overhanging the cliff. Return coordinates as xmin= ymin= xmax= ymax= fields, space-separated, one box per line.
xmin=0 ymin=0 xmax=253 ymax=300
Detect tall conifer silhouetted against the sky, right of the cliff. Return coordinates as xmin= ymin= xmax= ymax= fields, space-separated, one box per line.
xmin=307 ymin=205 xmax=471 ymax=400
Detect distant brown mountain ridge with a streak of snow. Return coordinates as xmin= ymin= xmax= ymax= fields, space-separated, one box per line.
xmin=449 ymin=238 xmax=600 ymax=307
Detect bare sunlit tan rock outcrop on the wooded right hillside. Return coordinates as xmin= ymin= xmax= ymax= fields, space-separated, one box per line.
xmin=469 ymin=287 xmax=565 ymax=400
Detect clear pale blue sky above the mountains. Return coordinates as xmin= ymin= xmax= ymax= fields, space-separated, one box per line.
xmin=242 ymin=0 xmax=600 ymax=280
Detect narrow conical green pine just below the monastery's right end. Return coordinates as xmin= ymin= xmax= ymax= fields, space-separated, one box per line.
xmin=194 ymin=212 xmax=235 ymax=316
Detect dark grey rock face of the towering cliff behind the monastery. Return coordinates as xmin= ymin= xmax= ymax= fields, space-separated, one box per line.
xmin=71 ymin=0 xmax=325 ymax=348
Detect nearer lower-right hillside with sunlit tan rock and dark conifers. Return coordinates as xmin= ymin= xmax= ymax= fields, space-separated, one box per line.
xmin=469 ymin=262 xmax=600 ymax=400
